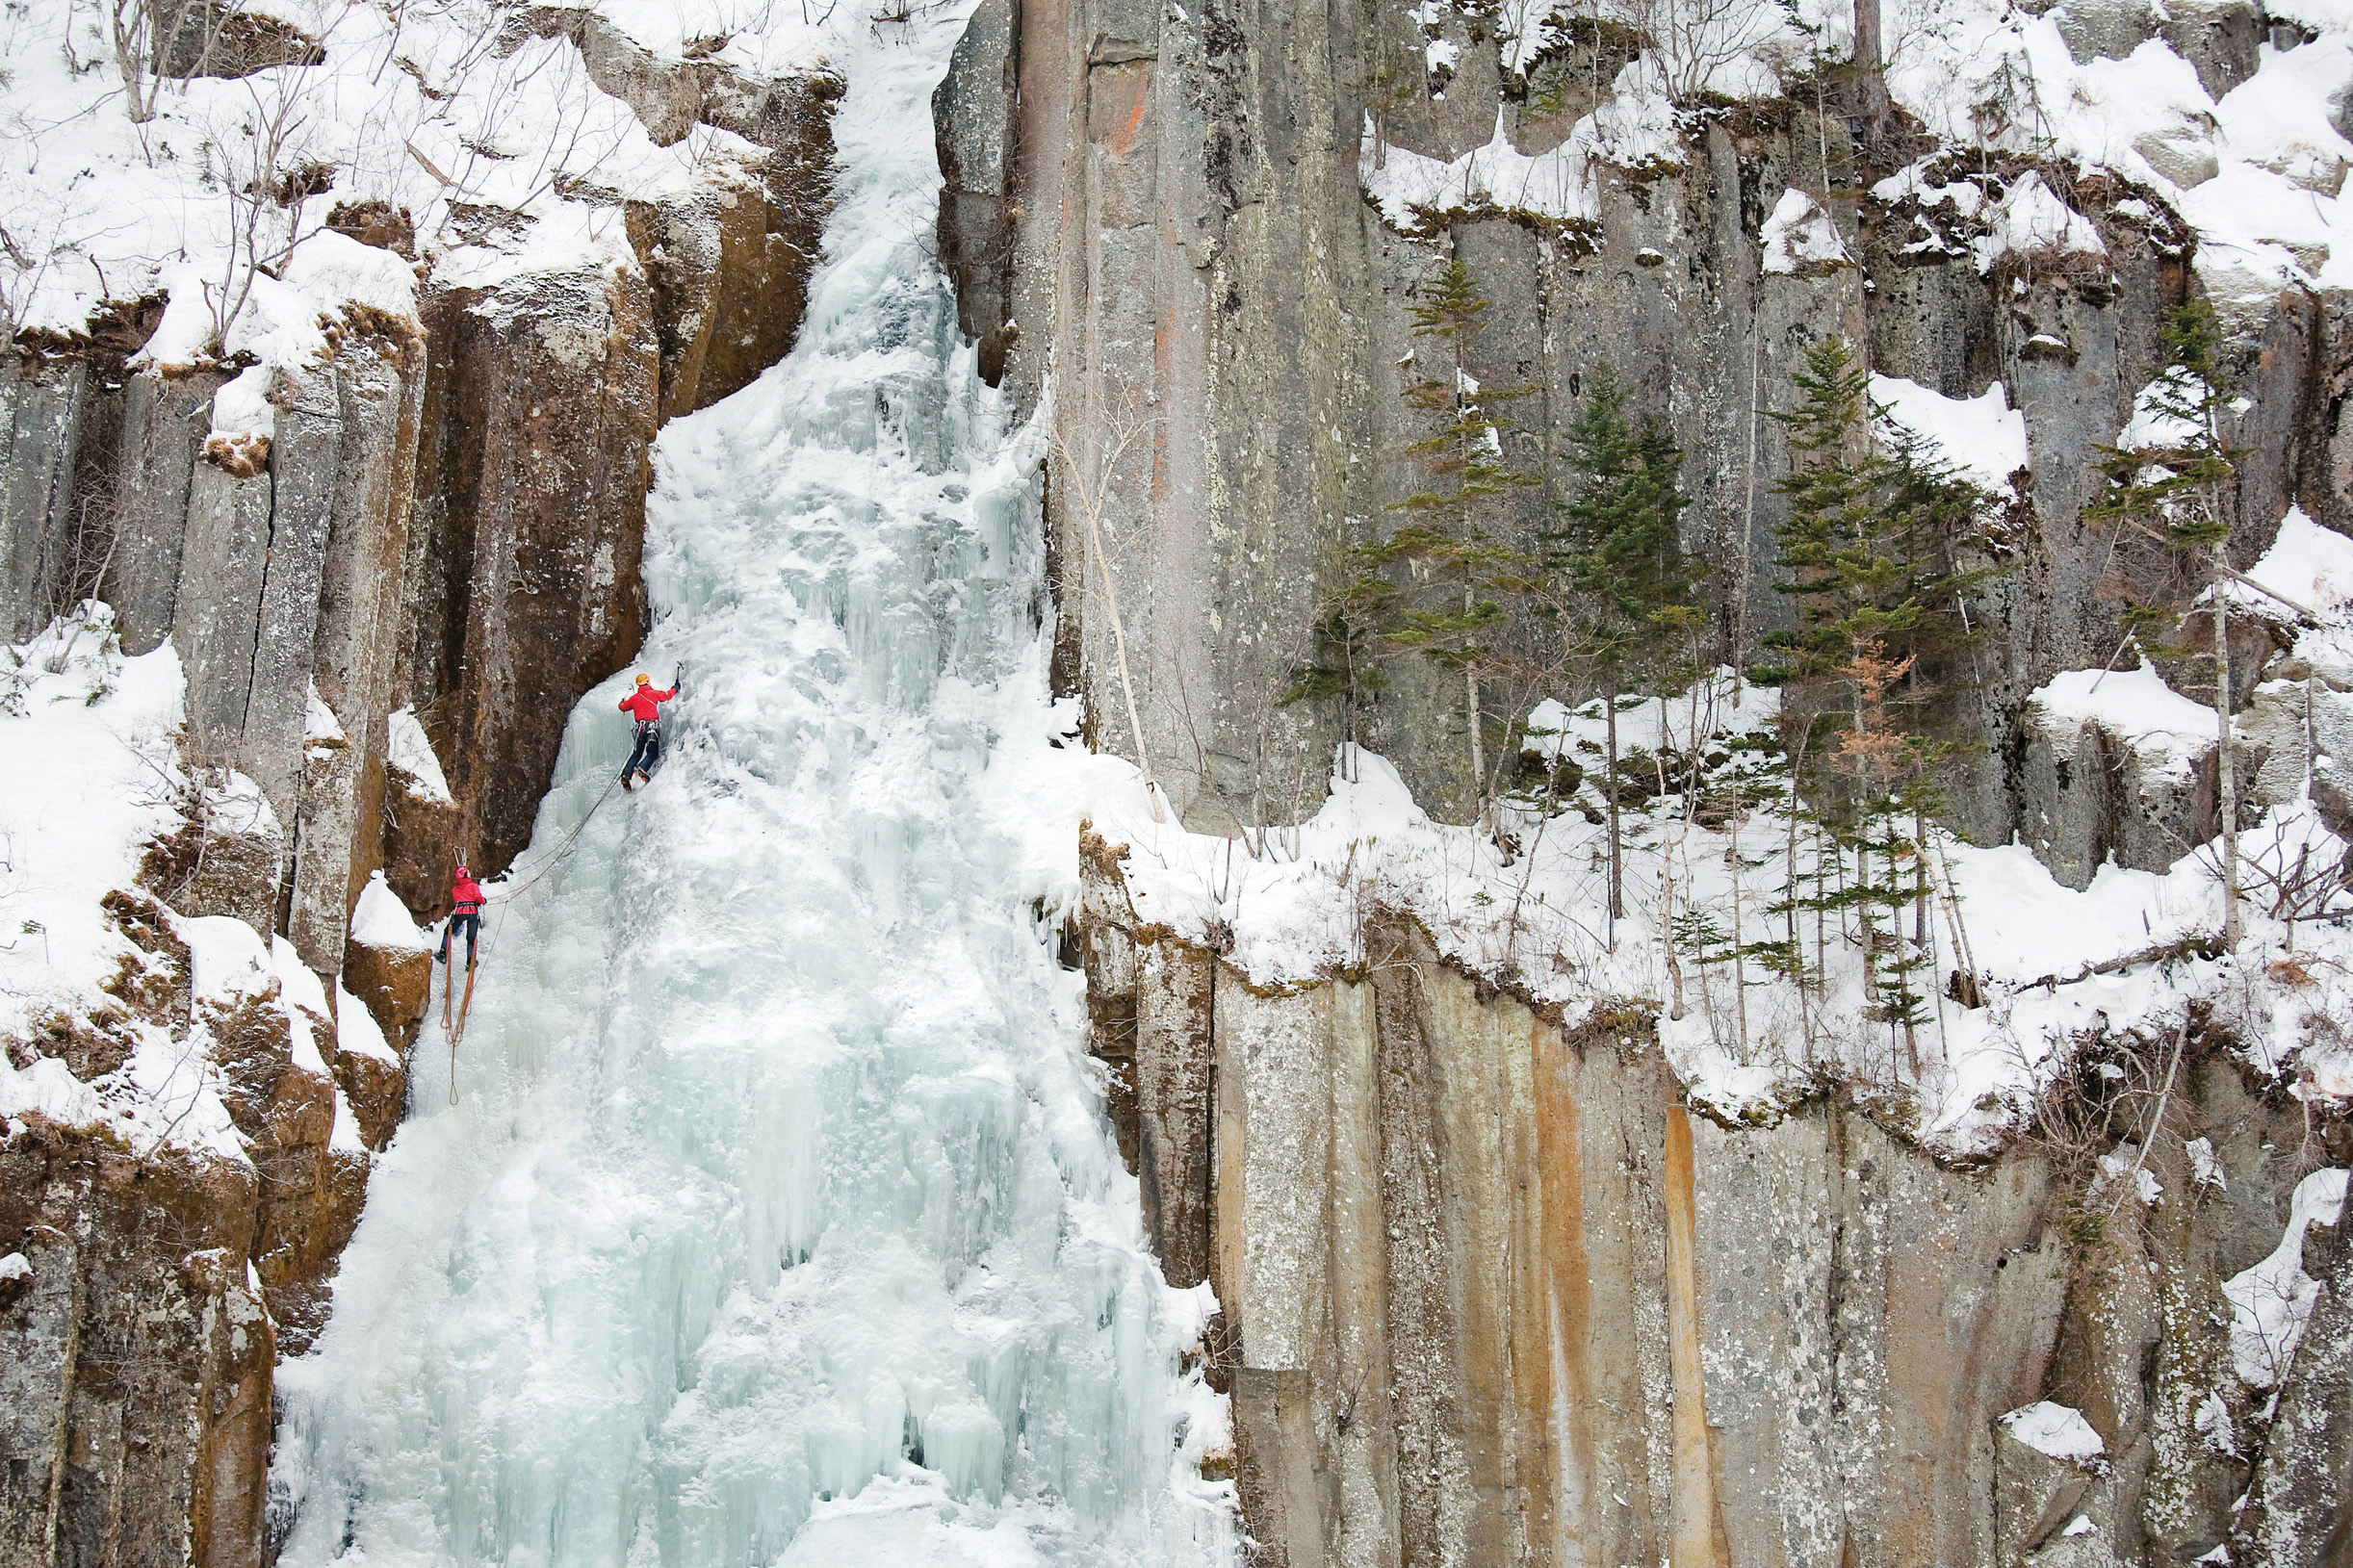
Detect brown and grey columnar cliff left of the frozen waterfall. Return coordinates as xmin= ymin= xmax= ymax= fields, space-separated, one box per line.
xmin=0 ymin=27 xmax=838 ymax=1568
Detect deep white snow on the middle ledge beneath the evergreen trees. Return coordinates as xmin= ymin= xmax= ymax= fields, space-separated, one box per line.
xmin=1053 ymin=649 xmax=2353 ymax=1157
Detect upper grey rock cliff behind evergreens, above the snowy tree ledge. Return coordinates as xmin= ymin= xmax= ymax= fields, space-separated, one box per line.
xmin=934 ymin=0 xmax=2353 ymax=846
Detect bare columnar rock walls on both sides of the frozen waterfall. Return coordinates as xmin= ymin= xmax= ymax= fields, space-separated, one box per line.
xmin=0 ymin=0 xmax=2353 ymax=1568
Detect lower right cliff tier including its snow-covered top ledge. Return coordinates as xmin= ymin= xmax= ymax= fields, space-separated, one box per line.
xmin=1023 ymin=667 xmax=2353 ymax=1561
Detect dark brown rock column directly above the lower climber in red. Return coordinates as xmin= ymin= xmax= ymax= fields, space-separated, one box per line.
xmin=396 ymin=268 xmax=659 ymax=893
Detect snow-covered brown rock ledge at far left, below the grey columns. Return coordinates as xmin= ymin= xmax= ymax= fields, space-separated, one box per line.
xmin=0 ymin=602 xmax=437 ymax=1561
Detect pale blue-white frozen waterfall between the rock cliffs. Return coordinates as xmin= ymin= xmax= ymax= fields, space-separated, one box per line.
xmin=273 ymin=14 xmax=1233 ymax=1568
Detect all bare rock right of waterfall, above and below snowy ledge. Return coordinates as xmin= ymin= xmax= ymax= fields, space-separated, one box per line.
xmin=934 ymin=0 xmax=2353 ymax=1566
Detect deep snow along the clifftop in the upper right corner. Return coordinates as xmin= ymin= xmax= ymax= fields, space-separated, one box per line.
xmin=1358 ymin=0 xmax=2353 ymax=322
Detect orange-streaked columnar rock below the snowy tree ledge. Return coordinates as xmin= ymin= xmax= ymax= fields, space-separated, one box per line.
xmin=1080 ymin=839 xmax=2353 ymax=1568
